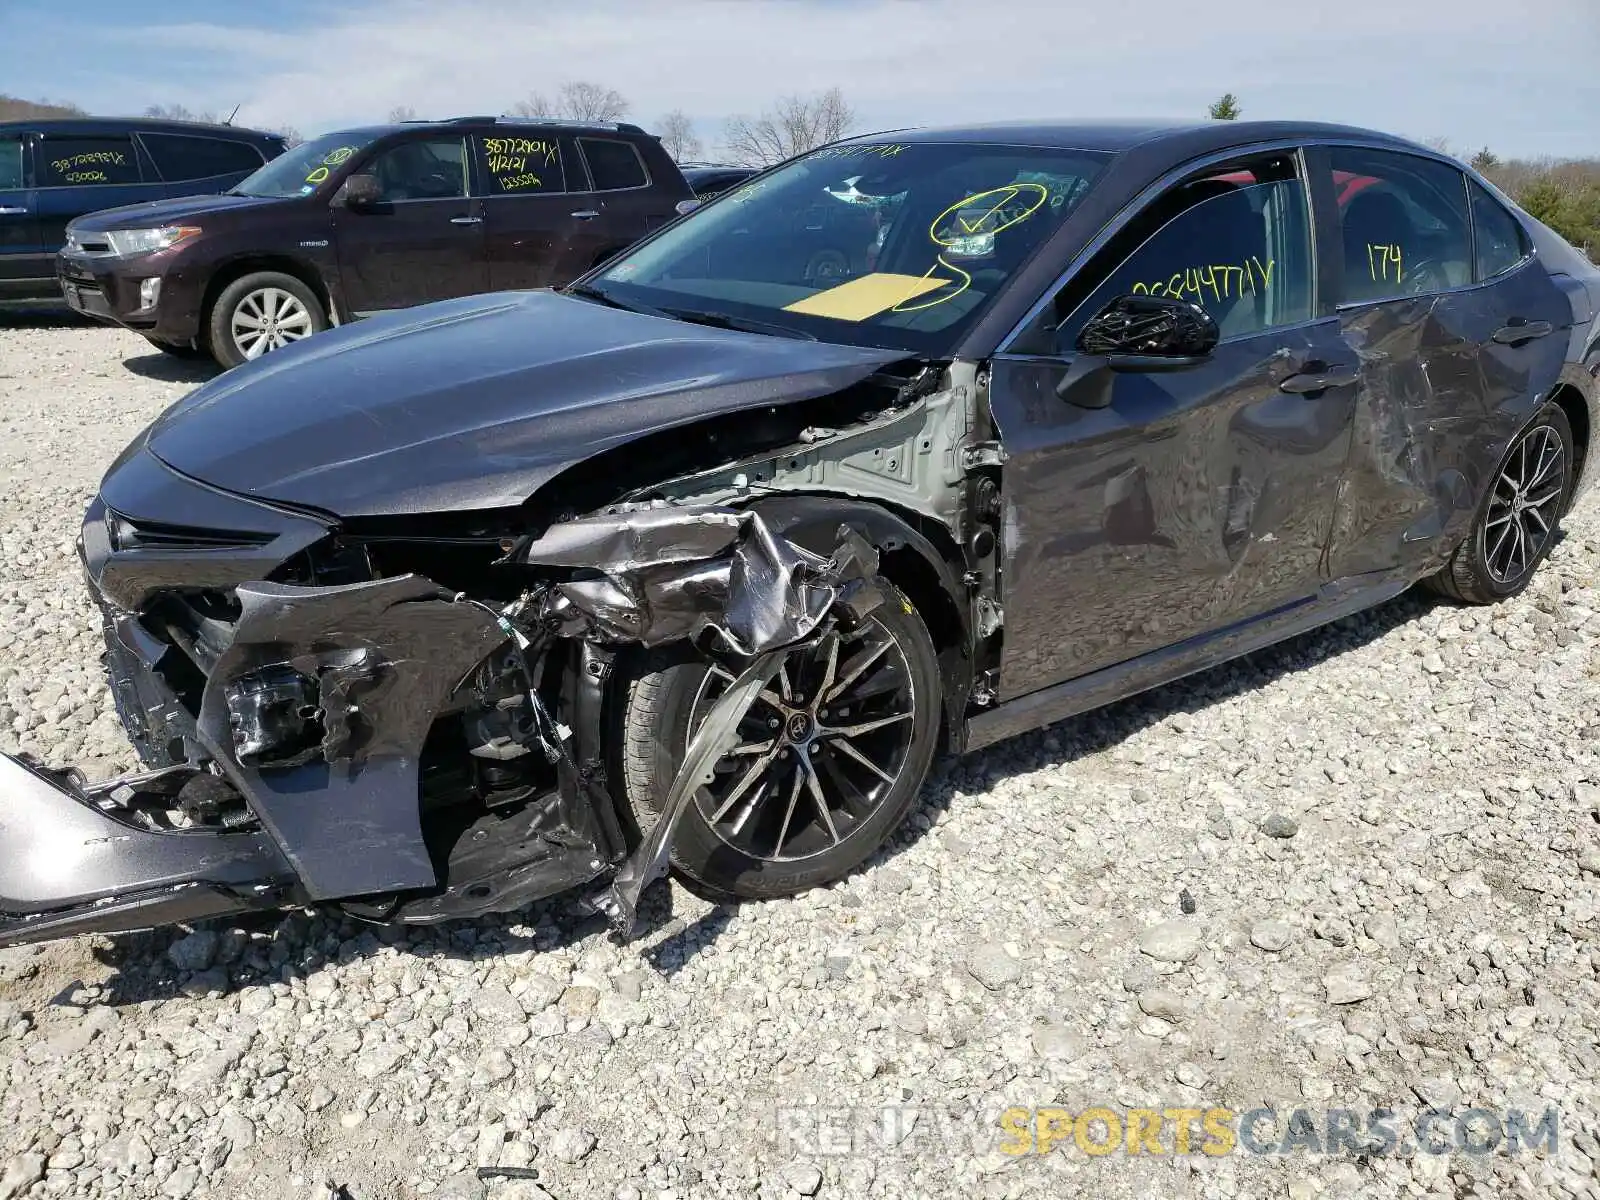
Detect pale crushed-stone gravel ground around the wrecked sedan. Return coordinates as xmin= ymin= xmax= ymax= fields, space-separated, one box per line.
xmin=0 ymin=317 xmax=1600 ymax=1200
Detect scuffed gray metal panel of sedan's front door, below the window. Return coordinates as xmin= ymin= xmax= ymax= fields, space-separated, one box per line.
xmin=990 ymin=320 xmax=1354 ymax=698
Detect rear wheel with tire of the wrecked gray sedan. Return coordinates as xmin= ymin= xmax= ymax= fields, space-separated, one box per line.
xmin=1422 ymin=403 xmax=1578 ymax=605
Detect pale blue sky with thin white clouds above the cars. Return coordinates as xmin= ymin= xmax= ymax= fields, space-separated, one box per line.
xmin=0 ymin=0 xmax=1600 ymax=157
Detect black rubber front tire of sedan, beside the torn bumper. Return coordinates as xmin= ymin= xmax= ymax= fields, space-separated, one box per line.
xmin=613 ymin=586 xmax=942 ymax=898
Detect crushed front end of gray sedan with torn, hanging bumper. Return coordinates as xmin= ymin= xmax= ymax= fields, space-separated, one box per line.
xmin=0 ymin=443 xmax=896 ymax=944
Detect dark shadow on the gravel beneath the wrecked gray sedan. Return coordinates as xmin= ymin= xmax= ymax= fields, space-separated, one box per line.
xmin=69 ymin=589 xmax=1450 ymax=1005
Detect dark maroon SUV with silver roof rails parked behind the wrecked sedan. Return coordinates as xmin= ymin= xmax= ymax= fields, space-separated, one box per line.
xmin=58 ymin=117 xmax=693 ymax=366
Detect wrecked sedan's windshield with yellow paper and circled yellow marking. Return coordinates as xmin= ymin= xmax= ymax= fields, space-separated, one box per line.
xmin=584 ymin=142 xmax=1109 ymax=355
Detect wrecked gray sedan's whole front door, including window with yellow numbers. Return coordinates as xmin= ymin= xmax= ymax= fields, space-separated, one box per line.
xmin=990 ymin=154 xmax=1357 ymax=699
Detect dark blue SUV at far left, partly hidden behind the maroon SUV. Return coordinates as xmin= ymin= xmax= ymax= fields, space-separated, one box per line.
xmin=0 ymin=118 xmax=283 ymax=301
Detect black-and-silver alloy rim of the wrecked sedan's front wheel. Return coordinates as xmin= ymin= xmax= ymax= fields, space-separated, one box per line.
xmin=690 ymin=619 xmax=917 ymax=862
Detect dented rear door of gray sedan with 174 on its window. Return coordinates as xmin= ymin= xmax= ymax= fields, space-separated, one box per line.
xmin=1318 ymin=146 xmax=1571 ymax=576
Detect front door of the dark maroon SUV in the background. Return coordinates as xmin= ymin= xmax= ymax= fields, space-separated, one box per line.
xmin=333 ymin=138 xmax=488 ymax=315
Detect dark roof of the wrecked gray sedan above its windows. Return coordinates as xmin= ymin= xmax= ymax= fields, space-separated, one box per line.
xmin=845 ymin=120 xmax=1421 ymax=154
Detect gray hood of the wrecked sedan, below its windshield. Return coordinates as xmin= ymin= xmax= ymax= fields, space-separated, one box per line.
xmin=147 ymin=291 xmax=906 ymax=517
